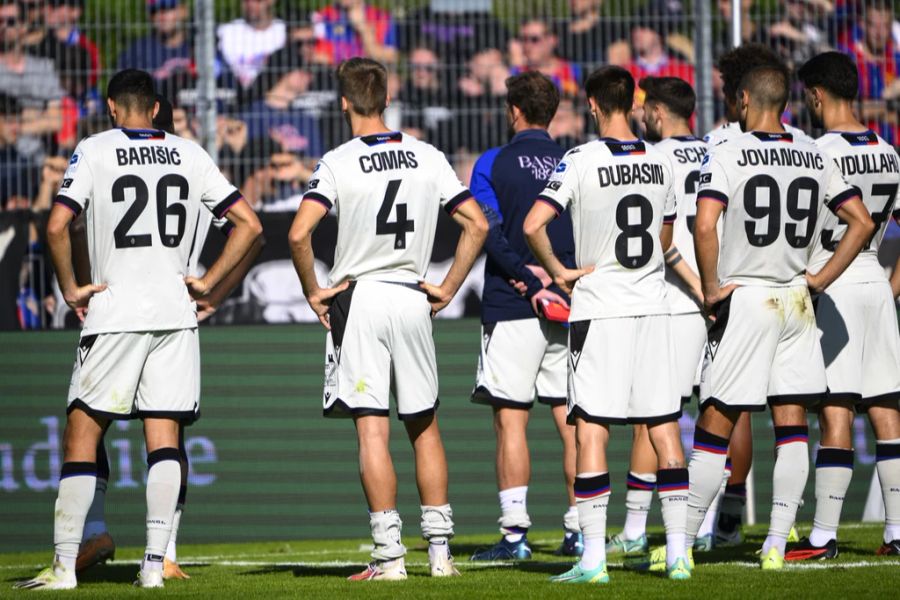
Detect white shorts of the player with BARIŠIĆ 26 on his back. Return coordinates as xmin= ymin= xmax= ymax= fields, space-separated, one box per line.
xmin=69 ymin=329 xmax=200 ymax=422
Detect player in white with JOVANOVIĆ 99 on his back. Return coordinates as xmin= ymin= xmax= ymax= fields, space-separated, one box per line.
xmin=688 ymin=65 xmax=873 ymax=570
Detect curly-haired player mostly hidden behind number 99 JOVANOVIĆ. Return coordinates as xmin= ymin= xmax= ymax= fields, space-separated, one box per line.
xmin=696 ymin=44 xmax=812 ymax=550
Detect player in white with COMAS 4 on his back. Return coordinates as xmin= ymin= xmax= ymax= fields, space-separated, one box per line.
xmin=290 ymin=58 xmax=488 ymax=581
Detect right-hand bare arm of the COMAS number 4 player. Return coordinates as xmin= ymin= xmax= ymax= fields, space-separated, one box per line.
xmin=420 ymin=198 xmax=488 ymax=315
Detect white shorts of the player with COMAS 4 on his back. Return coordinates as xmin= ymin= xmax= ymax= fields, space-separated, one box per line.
xmin=324 ymin=280 xmax=438 ymax=419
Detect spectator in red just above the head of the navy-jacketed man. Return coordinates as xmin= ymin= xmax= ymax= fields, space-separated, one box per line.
xmin=509 ymin=20 xmax=581 ymax=97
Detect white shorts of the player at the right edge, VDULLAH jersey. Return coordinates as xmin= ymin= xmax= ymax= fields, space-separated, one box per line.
xmin=815 ymin=281 xmax=900 ymax=408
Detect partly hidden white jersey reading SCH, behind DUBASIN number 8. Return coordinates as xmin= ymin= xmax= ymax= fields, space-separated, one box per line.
xmin=654 ymin=135 xmax=706 ymax=315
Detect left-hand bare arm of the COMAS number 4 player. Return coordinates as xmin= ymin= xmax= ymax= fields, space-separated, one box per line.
xmin=288 ymin=202 xmax=350 ymax=329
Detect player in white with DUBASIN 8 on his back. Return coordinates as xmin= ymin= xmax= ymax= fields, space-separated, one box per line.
xmin=524 ymin=66 xmax=690 ymax=584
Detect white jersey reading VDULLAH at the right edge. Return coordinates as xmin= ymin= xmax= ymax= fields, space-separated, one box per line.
xmin=809 ymin=131 xmax=900 ymax=287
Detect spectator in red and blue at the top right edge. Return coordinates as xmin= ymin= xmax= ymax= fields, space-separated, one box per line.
xmin=842 ymin=0 xmax=900 ymax=146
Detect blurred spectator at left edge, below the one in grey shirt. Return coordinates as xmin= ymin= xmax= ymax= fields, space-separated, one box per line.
xmin=0 ymin=93 xmax=33 ymax=210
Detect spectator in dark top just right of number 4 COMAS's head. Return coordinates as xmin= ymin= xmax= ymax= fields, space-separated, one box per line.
xmin=400 ymin=46 xmax=453 ymax=148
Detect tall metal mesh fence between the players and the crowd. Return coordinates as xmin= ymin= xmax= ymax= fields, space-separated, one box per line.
xmin=0 ymin=0 xmax=900 ymax=328
